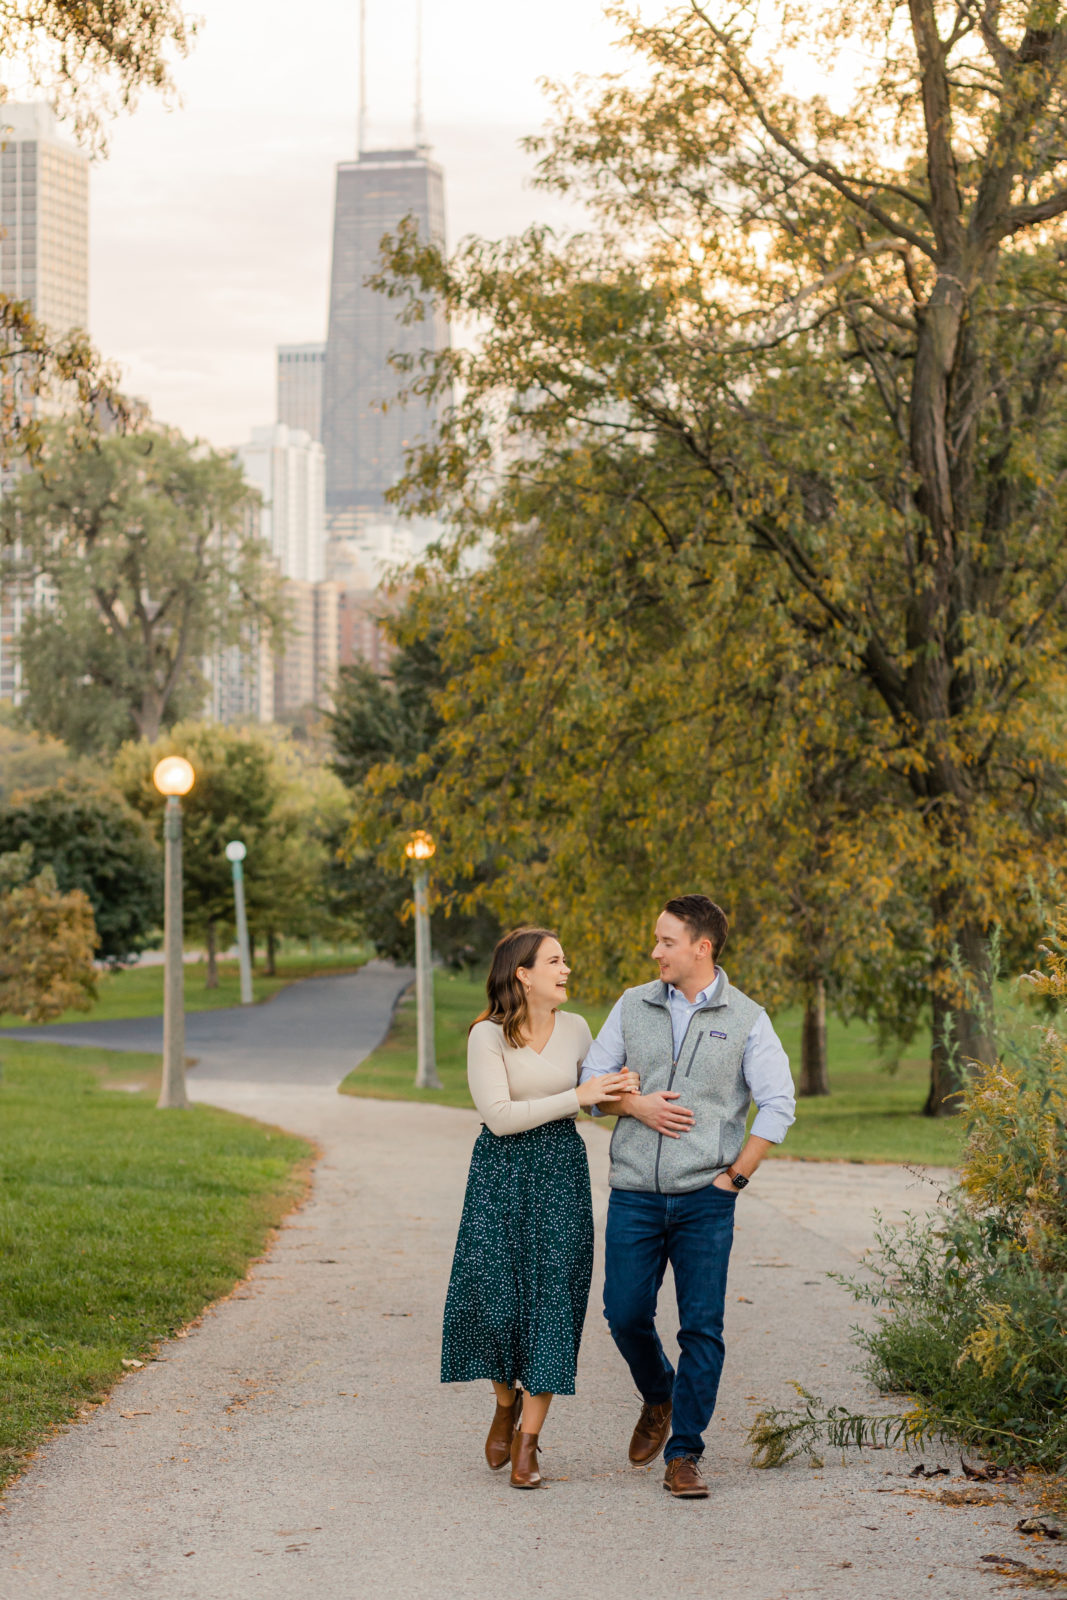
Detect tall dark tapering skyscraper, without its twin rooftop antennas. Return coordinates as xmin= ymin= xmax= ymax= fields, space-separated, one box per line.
xmin=322 ymin=144 xmax=448 ymax=582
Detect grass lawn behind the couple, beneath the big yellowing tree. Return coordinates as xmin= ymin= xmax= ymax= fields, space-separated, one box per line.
xmin=341 ymin=973 xmax=961 ymax=1166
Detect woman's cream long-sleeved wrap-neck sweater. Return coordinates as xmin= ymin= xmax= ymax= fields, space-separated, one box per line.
xmin=467 ymin=1011 xmax=592 ymax=1133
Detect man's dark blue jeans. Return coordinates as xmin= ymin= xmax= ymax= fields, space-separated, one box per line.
xmin=605 ymin=1184 xmax=737 ymax=1461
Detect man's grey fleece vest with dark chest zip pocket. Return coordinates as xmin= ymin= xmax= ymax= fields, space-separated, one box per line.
xmin=611 ymin=973 xmax=763 ymax=1195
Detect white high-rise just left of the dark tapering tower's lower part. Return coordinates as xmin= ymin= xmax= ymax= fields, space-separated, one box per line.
xmin=237 ymin=422 xmax=326 ymax=584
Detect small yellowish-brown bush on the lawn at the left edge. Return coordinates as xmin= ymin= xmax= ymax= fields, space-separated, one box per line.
xmin=0 ymin=845 xmax=96 ymax=1022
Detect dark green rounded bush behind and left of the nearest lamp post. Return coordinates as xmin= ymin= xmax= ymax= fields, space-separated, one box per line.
xmin=0 ymin=779 xmax=163 ymax=963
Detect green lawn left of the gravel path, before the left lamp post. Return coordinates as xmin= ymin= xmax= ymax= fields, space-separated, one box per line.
xmin=0 ymin=1040 xmax=312 ymax=1485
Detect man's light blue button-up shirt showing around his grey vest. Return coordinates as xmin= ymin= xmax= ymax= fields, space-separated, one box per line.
xmin=581 ymin=966 xmax=797 ymax=1144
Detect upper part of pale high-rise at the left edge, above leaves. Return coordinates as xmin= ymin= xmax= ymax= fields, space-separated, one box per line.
xmin=0 ymin=104 xmax=90 ymax=333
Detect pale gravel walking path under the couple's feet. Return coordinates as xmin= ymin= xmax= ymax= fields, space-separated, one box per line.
xmin=0 ymin=978 xmax=1049 ymax=1600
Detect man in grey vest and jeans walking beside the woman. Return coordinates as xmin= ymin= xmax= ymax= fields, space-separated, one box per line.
xmin=581 ymin=894 xmax=795 ymax=1499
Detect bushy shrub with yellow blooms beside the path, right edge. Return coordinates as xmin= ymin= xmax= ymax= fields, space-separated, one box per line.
xmin=750 ymin=907 xmax=1067 ymax=1472
